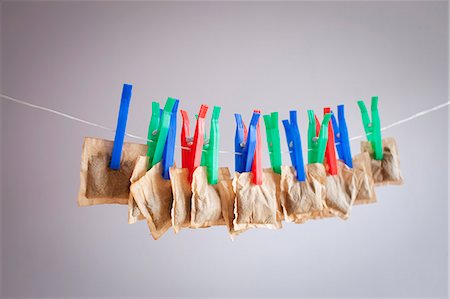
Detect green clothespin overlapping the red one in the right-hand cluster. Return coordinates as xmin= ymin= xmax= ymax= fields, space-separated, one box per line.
xmin=308 ymin=110 xmax=331 ymax=164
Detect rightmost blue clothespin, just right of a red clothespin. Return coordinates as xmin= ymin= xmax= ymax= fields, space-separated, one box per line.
xmin=331 ymin=105 xmax=353 ymax=168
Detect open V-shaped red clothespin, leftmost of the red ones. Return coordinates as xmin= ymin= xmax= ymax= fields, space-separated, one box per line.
xmin=181 ymin=105 xmax=208 ymax=181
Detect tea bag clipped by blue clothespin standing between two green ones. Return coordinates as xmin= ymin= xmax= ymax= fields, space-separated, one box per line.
xmin=281 ymin=163 xmax=326 ymax=224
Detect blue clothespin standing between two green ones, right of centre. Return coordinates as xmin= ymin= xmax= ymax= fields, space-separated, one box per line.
xmin=283 ymin=110 xmax=306 ymax=182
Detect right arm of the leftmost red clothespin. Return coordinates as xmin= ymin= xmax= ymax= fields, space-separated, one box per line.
xmin=188 ymin=105 xmax=208 ymax=180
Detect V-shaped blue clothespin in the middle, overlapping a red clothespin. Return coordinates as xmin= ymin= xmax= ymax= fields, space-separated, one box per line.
xmin=234 ymin=111 xmax=261 ymax=173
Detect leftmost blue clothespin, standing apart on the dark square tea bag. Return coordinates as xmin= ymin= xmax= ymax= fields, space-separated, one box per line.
xmin=109 ymin=84 xmax=133 ymax=170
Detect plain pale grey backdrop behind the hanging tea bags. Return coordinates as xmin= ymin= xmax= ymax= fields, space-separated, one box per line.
xmin=1 ymin=2 xmax=448 ymax=298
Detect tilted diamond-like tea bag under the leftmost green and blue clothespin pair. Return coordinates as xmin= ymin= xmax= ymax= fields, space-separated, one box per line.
xmin=130 ymin=156 xmax=172 ymax=240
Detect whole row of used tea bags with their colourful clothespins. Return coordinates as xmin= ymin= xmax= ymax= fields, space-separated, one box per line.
xmin=78 ymin=87 xmax=402 ymax=239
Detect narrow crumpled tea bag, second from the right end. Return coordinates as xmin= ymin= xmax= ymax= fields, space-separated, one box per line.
xmin=353 ymin=152 xmax=377 ymax=205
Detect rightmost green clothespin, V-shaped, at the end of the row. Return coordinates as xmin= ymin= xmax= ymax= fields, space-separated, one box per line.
xmin=358 ymin=97 xmax=383 ymax=160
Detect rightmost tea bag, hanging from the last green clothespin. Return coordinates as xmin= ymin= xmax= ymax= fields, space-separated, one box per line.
xmin=361 ymin=138 xmax=403 ymax=186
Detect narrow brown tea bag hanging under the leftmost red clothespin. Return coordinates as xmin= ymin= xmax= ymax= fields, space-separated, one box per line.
xmin=170 ymin=167 xmax=192 ymax=233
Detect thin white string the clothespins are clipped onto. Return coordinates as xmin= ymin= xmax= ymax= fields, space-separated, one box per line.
xmin=0 ymin=94 xmax=450 ymax=155
